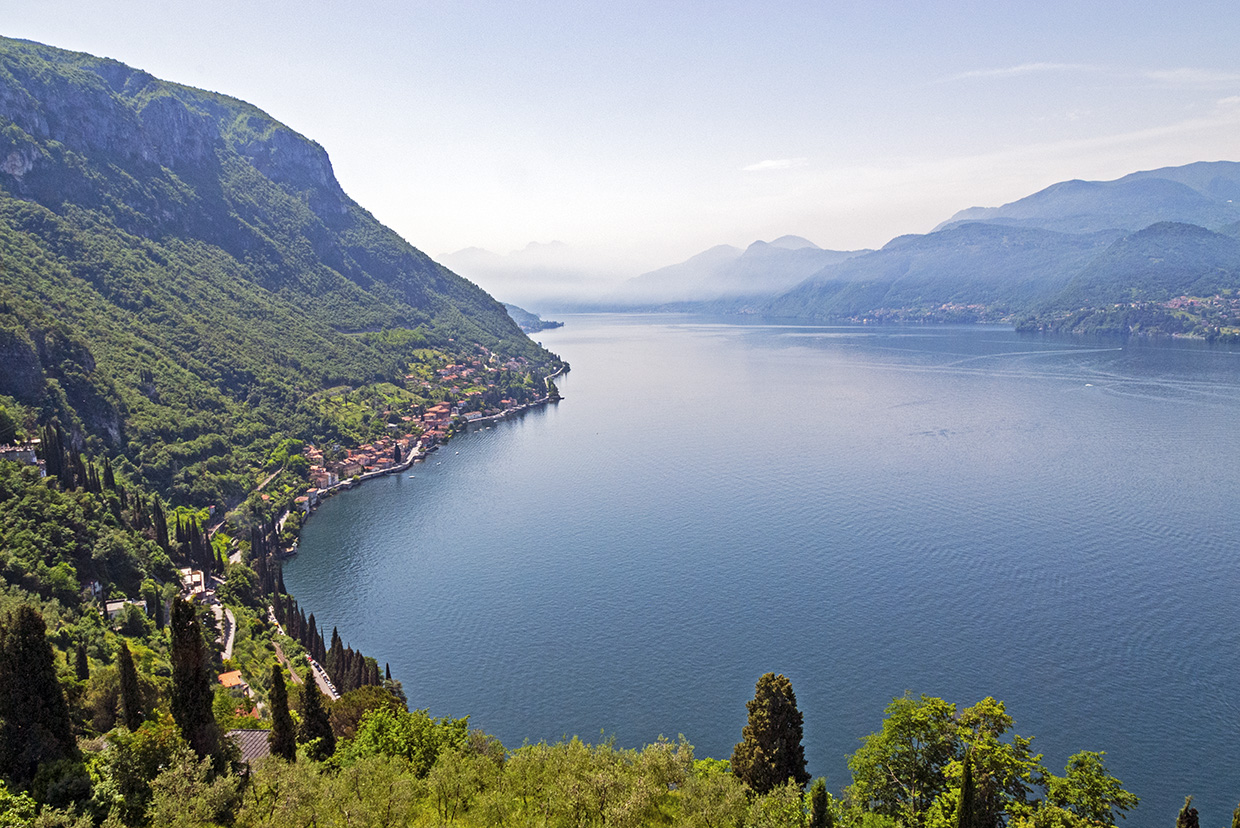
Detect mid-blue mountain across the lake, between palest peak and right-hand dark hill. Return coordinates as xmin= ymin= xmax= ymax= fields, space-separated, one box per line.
xmin=750 ymin=222 xmax=1118 ymax=319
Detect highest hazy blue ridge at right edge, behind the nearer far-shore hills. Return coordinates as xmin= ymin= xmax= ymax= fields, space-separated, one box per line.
xmin=935 ymin=161 xmax=1240 ymax=233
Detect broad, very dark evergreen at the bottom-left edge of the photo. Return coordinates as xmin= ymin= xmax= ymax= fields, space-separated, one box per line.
xmin=0 ymin=604 xmax=77 ymax=788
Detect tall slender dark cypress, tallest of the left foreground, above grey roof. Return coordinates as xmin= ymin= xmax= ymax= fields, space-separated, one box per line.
xmin=170 ymin=599 xmax=219 ymax=756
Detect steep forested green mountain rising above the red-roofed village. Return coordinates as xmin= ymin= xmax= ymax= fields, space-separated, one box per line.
xmin=0 ymin=38 xmax=557 ymax=504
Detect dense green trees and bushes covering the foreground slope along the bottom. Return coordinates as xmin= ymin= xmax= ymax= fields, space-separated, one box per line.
xmin=0 ymin=575 xmax=1160 ymax=828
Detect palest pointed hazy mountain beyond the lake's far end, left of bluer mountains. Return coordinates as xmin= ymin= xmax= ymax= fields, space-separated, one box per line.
xmin=615 ymin=236 xmax=864 ymax=304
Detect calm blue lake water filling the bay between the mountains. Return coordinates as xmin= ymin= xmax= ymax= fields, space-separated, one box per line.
xmin=285 ymin=315 xmax=1240 ymax=826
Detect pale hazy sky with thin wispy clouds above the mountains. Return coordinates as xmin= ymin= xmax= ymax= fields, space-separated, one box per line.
xmin=0 ymin=0 xmax=1240 ymax=271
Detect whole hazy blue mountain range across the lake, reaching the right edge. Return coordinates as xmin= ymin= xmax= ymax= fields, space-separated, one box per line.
xmin=615 ymin=161 xmax=1240 ymax=337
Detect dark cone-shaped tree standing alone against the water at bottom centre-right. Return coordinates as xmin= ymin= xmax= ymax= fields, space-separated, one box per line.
xmin=732 ymin=673 xmax=810 ymax=793
